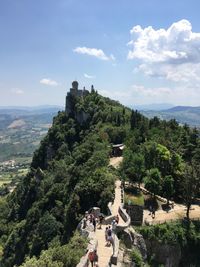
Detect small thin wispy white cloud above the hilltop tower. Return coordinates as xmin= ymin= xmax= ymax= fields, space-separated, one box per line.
xmin=73 ymin=47 xmax=115 ymax=60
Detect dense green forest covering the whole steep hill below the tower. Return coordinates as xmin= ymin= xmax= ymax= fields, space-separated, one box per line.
xmin=0 ymin=90 xmax=200 ymax=267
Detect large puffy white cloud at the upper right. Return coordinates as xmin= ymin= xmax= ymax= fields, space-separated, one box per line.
xmin=128 ymin=20 xmax=200 ymax=82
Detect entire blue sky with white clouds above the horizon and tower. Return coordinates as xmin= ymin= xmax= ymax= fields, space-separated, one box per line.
xmin=0 ymin=0 xmax=200 ymax=106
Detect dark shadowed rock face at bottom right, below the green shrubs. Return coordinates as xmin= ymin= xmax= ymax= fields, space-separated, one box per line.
xmin=145 ymin=240 xmax=181 ymax=267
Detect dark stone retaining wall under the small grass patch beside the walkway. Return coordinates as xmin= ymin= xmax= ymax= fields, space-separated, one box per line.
xmin=125 ymin=204 xmax=143 ymax=225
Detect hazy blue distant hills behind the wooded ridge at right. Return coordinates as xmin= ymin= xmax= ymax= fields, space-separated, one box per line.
xmin=140 ymin=106 xmax=200 ymax=127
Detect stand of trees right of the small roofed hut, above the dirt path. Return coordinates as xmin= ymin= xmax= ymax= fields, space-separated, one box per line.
xmin=120 ymin=111 xmax=200 ymax=219
